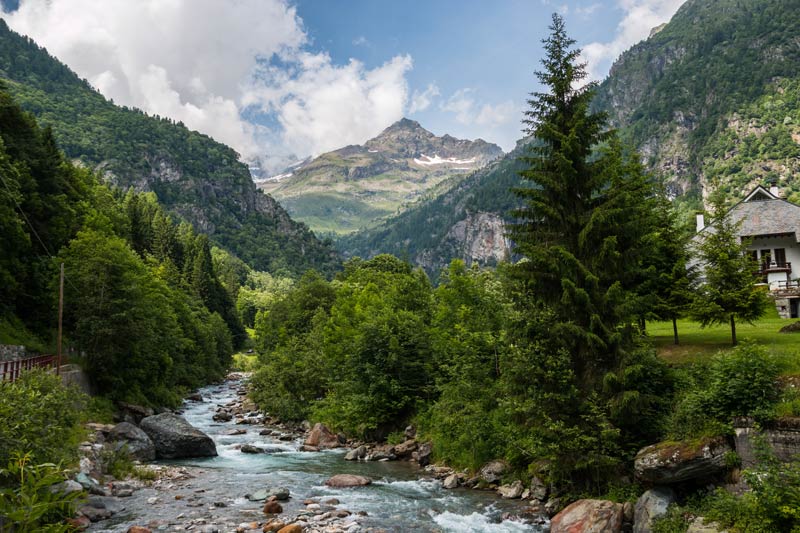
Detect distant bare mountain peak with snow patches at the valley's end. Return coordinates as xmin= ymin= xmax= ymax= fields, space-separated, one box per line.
xmin=259 ymin=119 xmax=503 ymax=234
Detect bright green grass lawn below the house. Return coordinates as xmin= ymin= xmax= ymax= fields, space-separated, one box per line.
xmin=647 ymin=313 xmax=800 ymax=372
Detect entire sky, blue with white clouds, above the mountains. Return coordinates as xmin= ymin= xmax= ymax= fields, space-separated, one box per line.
xmin=0 ymin=0 xmax=684 ymax=173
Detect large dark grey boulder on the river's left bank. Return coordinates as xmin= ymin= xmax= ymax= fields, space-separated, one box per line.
xmin=141 ymin=413 xmax=217 ymax=459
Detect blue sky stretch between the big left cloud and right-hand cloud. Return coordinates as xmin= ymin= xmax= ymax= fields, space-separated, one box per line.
xmin=296 ymin=0 xmax=624 ymax=150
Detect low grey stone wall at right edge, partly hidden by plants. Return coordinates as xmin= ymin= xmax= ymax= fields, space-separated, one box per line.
xmin=734 ymin=417 xmax=800 ymax=468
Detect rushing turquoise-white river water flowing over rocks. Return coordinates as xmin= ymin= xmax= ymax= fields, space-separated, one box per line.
xmin=90 ymin=381 xmax=544 ymax=533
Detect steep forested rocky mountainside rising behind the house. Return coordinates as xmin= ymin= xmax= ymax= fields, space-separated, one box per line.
xmin=595 ymin=0 xmax=800 ymax=203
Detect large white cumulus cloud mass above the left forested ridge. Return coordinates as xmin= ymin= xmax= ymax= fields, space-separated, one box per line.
xmin=2 ymin=0 xmax=412 ymax=168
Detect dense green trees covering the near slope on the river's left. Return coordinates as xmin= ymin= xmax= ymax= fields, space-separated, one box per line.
xmin=0 ymin=87 xmax=244 ymax=404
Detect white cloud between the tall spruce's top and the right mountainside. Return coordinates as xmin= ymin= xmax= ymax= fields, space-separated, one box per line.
xmin=583 ymin=0 xmax=686 ymax=80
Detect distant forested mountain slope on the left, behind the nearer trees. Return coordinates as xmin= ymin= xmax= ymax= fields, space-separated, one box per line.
xmin=0 ymin=20 xmax=337 ymax=275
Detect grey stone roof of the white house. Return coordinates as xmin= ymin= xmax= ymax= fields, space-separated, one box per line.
xmin=730 ymin=198 xmax=800 ymax=242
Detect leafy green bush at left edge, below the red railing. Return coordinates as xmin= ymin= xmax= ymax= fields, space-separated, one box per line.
xmin=0 ymin=370 xmax=88 ymax=464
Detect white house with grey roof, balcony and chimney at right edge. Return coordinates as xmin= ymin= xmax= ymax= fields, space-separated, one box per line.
xmin=697 ymin=186 xmax=800 ymax=318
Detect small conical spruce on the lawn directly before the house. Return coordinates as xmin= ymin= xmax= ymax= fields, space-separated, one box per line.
xmin=691 ymin=195 xmax=769 ymax=346
